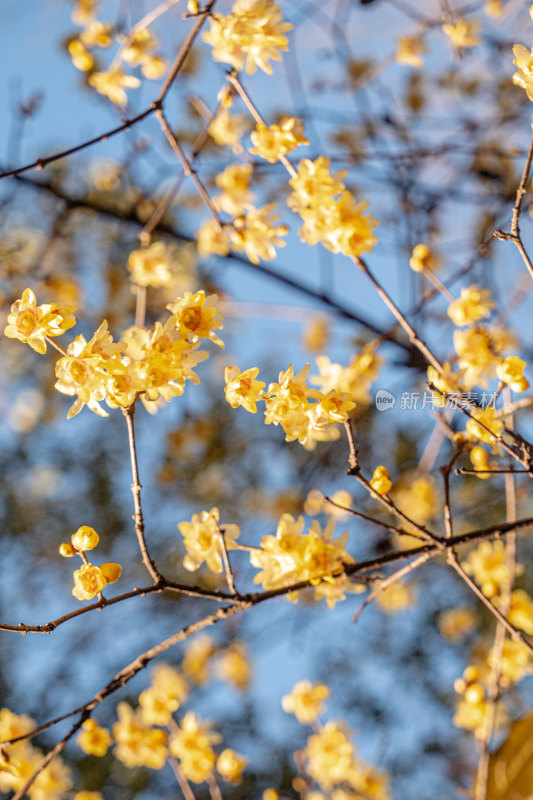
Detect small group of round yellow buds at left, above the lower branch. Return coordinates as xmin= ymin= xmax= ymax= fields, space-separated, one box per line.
xmin=59 ymin=525 xmax=122 ymax=600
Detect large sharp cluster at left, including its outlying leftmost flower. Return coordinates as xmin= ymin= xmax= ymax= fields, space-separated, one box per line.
xmin=5 ymin=288 xmax=224 ymax=419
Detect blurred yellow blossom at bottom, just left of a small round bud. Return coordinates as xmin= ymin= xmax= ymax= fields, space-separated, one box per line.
xmin=169 ymin=711 xmax=220 ymax=783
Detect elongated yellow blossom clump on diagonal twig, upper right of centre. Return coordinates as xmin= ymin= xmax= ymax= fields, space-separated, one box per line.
xmin=287 ymin=156 xmax=378 ymax=258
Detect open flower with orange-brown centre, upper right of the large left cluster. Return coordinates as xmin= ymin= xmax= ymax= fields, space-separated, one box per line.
xmin=167 ymin=289 xmax=224 ymax=347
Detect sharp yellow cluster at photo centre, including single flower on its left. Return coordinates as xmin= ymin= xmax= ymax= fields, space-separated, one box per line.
xmin=225 ymin=364 xmax=355 ymax=450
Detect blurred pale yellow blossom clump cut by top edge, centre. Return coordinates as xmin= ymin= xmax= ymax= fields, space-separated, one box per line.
xmin=203 ymin=0 xmax=292 ymax=75
